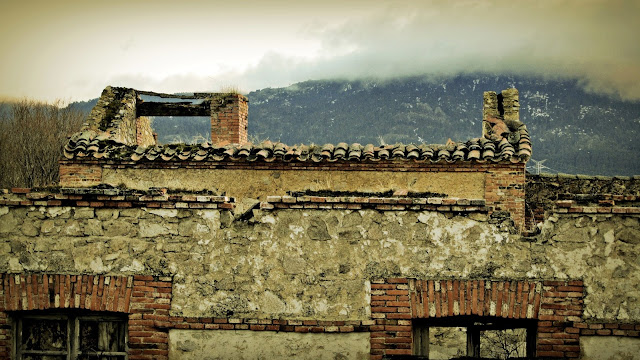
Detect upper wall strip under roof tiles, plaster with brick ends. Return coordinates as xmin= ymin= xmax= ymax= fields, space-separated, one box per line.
xmin=60 ymin=160 xmax=525 ymax=229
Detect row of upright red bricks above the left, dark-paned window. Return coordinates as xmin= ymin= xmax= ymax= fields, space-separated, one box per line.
xmin=0 ymin=274 xmax=133 ymax=313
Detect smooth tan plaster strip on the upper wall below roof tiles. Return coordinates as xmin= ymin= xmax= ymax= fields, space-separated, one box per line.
xmin=102 ymin=168 xmax=485 ymax=200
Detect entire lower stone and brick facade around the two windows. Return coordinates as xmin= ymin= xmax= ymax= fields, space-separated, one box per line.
xmin=0 ymin=189 xmax=640 ymax=359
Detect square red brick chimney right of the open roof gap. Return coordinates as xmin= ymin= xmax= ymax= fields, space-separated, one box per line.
xmin=211 ymin=94 xmax=249 ymax=146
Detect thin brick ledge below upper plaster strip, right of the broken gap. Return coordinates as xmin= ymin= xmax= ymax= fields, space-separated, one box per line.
xmin=260 ymin=196 xmax=489 ymax=213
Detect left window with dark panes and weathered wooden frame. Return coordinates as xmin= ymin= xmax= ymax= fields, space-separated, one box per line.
xmin=15 ymin=312 xmax=127 ymax=360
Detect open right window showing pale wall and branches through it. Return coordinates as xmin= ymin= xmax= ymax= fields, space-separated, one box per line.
xmin=413 ymin=316 xmax=537 ymax=359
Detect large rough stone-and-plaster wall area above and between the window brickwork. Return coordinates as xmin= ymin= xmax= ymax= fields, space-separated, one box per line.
xmin=0 ymin=207 xmax=640 ymax=321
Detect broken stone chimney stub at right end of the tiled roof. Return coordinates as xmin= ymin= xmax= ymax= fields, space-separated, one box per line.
xmin=482 ymin=88 xmax=520 ymax=136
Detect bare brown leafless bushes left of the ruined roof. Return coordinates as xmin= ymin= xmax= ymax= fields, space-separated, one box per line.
xmin=0 ymin=99 xmax=86 ymax=188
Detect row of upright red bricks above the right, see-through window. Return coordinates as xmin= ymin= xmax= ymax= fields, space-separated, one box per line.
xmin=408 ymin=279 xmax=543 ymax=319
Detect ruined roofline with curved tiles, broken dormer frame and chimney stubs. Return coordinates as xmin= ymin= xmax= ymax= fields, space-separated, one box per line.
xmin=64 ymin=87 xmax=531 ymax=163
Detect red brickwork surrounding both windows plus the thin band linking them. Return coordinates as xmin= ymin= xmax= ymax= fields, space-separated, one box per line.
xmin=0 ymin=274 xmax=640 ymax=359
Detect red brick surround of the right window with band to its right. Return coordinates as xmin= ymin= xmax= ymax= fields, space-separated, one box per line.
xmin=364 ymin=278 xmax=604 ymax=359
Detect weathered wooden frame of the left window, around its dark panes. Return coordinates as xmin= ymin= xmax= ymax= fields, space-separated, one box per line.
xmin=12 ymin=311 xmax=129 ymax=360
